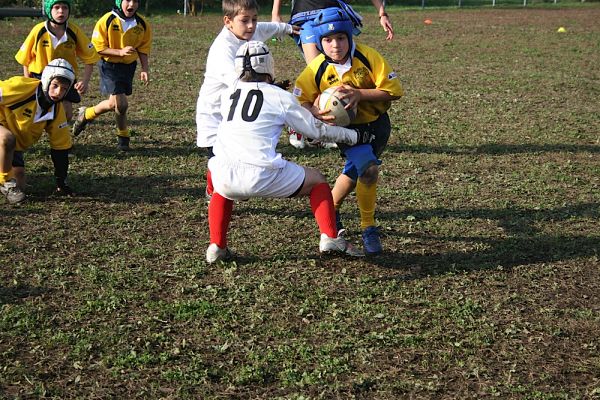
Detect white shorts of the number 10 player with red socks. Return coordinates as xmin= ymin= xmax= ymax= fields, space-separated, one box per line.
xmin=208 ymin=156 xmax=305 ymax=200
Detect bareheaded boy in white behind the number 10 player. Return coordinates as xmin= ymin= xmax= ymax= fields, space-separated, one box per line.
xmin=196 ymin=0 xmax=298 ymax=197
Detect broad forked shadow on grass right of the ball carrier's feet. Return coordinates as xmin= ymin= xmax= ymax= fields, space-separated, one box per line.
xmin=371 ymin=203 xmax=600 ymax=278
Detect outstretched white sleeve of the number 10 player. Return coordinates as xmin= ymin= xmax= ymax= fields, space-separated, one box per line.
xmin=282 ymin=92 xmax=358 ymax=145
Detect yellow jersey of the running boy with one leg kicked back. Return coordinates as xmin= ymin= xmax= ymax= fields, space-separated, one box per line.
xmin=92 ymin=11 xmax=152 ymax=64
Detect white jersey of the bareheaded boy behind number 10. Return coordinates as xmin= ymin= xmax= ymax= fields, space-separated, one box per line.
xmin=196 ymin=22 xmax=292 ymax=147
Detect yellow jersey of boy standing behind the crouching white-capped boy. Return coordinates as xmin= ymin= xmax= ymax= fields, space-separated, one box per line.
xmin=15 ymin=22 xmax=100 ymax=74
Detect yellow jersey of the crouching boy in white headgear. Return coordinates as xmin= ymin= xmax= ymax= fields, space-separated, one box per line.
xmin=0 ymin=76 xmax=72 ymax=151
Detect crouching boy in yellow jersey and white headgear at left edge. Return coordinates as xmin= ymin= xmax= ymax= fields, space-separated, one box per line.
xmin=0 ymin=58 xmax=75 ymax=204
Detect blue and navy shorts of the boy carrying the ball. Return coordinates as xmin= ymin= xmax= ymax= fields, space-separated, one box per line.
xmin=338 ymin=113 xmax=392 ymax=181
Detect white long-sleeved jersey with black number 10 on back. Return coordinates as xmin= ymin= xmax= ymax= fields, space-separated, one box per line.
xmin=213 ymin=81 xmax=357 ymax=169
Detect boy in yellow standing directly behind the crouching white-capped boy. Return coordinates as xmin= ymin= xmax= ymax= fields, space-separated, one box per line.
xmin=15 ymin=0 xmax=100 ymax=121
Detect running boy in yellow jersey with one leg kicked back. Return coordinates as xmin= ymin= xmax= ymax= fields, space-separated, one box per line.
xmin=73 ymin=0 xmax=152 ymax=151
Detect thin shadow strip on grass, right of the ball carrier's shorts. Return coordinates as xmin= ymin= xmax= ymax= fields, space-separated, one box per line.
xmin=384 ymin=143 xmax=600 ymax=157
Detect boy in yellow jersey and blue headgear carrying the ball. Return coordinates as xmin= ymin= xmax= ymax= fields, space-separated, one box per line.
xmin=294 ymin=8 xmax=403 ymax=255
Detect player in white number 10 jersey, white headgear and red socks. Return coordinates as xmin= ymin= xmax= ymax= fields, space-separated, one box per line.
xmin=206 ymin=41 xmax=371 ymax=263
